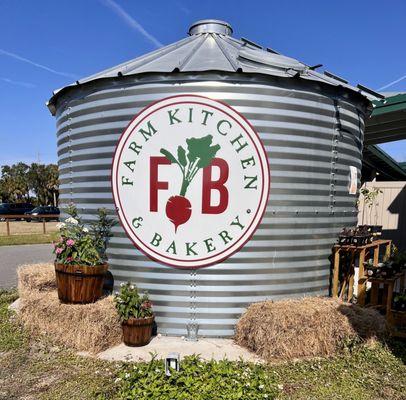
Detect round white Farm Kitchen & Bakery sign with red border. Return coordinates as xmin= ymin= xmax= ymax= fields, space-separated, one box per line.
xmin=112 ymin=95 xmax=270 ymax=268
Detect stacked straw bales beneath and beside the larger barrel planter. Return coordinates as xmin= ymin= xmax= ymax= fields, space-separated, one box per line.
xmin=18 ymin=264 xmax=122 ymax=353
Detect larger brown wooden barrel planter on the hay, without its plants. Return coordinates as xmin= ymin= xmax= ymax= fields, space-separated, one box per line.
xmin=55 ymin=263 xmax=108 ymax=304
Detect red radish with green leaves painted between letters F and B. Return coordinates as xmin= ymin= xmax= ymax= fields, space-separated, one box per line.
xmin=161 ymin=135 xmax=220 ymax=233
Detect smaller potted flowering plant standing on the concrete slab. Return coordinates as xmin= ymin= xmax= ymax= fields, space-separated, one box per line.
xmin=114 ymin=282 xmax=154 ymax=346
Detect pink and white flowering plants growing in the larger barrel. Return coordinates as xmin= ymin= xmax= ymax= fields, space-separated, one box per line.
xmin=54 ymin=204 xmax=115 ymax=266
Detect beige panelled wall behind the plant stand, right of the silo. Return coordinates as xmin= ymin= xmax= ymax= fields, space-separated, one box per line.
xmin=358 ymin=182 xmax=406 ymax=250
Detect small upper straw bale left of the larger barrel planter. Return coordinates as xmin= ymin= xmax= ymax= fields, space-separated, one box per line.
xmin=17 ymin=263 xmax=56 ymax=293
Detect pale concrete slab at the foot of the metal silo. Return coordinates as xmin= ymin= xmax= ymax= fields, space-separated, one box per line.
xmin=97 ymin=336 xmax=264 ymax=363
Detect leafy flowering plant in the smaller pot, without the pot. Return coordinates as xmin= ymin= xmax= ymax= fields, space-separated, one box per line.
xmin=114 ymin=282 xmax=154 ymax=321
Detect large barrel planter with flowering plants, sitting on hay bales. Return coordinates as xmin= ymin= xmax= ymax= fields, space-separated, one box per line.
xmin=54 ymin=204 xmax=115 ymax=304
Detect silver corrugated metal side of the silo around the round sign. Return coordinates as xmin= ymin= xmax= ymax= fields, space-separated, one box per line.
xmin=57 ymin=74 xmax=364 ymax=336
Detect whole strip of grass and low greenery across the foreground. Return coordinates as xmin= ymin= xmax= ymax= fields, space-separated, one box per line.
xmin=0 ymin=291 xmax=406 ymax=400
